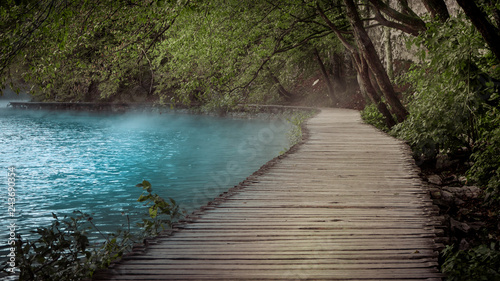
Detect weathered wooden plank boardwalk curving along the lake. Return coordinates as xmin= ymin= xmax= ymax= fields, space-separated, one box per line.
xmin=95 ymin=109 xmax=441 ymax=280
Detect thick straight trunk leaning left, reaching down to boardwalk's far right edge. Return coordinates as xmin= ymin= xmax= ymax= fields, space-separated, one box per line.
xmin=344 ymin=0 xmax=408 ymax=122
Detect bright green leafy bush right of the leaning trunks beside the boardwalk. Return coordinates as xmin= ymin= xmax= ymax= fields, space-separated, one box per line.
xmin=393 ymin=16 xmax=491 ymax=159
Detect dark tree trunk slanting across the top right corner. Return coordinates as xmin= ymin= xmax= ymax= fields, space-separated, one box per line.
xmin=457 ymin=0 xmax=500 ymax=60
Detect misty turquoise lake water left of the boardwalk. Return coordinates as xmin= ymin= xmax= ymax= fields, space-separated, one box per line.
xmin=0 ymin=105 xmax=289 ymax=260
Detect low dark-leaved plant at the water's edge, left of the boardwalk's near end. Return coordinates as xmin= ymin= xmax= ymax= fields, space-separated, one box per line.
xmin=2 ymin=180 xmax=182 ymax=281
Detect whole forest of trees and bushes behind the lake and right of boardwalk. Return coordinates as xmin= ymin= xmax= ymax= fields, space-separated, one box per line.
xmin=0 ymin=0 xmax=500 ymax=280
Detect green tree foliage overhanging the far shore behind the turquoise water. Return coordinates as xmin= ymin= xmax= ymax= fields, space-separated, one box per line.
xmin=0 ymin=0 xmax=343 ymax=108
